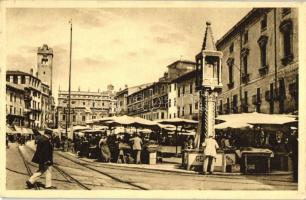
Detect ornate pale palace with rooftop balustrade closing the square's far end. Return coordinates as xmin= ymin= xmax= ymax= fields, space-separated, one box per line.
xmin=57 ymin=87 xmax=117 ymax=128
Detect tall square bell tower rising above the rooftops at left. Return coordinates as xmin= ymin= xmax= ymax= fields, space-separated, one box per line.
xmin=37 ymin=44 xmax=53 ymax=92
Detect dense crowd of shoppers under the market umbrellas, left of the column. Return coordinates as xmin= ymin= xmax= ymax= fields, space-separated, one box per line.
xmin=53 ymin=133 xmax=158 ymax=164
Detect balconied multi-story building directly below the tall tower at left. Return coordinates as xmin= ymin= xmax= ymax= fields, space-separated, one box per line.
xmin=6 ymin=69 xmax=52 ymax=128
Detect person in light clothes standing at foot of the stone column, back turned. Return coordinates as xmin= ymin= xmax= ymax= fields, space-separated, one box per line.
xmin=203 ymin=135 xmax=219 ymax=174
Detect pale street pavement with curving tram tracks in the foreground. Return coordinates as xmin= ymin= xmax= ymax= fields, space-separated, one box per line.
xmin=6 ymin=143 xmax=297 ymax=190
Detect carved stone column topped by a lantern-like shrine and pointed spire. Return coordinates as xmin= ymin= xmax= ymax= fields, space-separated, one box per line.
xmin=195 ymin=22 xmax=223 ymax=141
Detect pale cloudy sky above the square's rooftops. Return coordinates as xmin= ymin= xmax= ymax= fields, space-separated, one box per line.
xmin=6 ymin=8 xmax=250 ymax=99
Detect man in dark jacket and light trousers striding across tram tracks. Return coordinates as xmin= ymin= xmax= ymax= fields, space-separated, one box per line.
xmin=26 ymin=131 xmax=56 ymax=189
